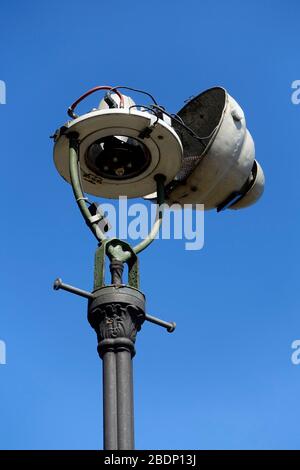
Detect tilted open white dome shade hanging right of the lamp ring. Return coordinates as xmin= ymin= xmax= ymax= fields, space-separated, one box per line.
xmin=167 ymin=87 xmax=264 ymax=209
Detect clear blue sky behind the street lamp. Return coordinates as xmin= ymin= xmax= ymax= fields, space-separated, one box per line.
xmin=0 ymin=0 xmax=300 ymax=449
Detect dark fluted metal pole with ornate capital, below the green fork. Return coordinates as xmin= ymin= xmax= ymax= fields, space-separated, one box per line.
xmin=88 ymin=259 xmax=145 ymax=450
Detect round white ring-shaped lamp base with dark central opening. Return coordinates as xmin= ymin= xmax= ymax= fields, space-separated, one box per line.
xmin=54 ymin=93 xmax=183 ymax=198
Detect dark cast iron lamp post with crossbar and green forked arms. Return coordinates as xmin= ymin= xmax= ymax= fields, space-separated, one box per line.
xmin=54 ymin=86 xmax=180 ymax=450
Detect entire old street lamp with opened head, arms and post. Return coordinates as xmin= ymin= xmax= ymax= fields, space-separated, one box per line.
xmin=53 ymin=86 xmax=264 ymax=450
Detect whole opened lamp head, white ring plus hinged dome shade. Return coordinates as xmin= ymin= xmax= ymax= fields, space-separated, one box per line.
xmin=54 ymin=87 xmax=264 ymax=211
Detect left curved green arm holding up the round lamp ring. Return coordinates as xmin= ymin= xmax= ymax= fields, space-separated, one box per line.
xmin=68 ymin=134 xmax=106 ymax=242
